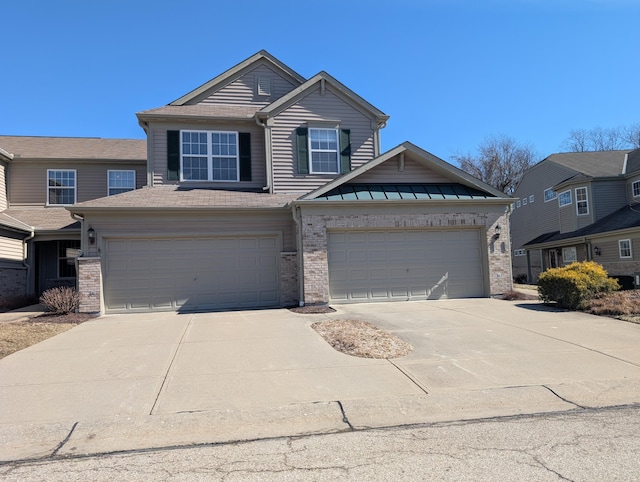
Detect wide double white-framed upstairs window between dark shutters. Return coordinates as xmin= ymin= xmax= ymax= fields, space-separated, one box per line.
xmin=180 ymin=131 xmax=240 ymax=181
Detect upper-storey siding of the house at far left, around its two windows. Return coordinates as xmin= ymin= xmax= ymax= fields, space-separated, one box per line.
xmin=9 ymin=160 xmax=146 ymax=207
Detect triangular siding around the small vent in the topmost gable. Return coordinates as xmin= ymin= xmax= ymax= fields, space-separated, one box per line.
xmin=199 ymin=65 xmax=296 ymax=107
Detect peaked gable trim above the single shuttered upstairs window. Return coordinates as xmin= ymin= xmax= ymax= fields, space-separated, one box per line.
xmin=256 ymin=71 xmax=389 ymax=123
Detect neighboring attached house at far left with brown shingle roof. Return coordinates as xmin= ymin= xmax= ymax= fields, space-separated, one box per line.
xmin=0 ymin=136 xmax=146 ymax=296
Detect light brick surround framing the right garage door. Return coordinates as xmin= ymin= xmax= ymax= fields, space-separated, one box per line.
xmin=301 ymin=213 xmax=513 ymax=304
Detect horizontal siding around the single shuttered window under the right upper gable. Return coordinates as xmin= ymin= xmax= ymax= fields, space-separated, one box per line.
xmin=271 ymin=86 xmax=375 ymax=192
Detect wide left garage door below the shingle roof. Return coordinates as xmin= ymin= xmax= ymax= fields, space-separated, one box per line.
xmin=104 ymin=236 xmax=279 ymax=311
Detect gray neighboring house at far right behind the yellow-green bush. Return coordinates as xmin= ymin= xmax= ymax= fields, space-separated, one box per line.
xmin=510 ymin=149 xmax=640 ymax=284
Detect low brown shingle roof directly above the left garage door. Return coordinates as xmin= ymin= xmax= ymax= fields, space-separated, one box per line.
xmin=69 ymin=186 xmax=300 ymax=213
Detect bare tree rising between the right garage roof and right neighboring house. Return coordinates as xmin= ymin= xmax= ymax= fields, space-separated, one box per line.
xmin=452 ymin=135 xmax=536 ymax=194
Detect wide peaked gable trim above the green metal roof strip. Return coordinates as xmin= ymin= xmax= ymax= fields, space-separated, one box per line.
xmin=300 ymin=142 xmax=512 ymax=202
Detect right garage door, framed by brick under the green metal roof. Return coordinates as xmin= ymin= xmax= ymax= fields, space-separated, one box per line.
xmin=328 ymin=229 xmax=485 ymax=302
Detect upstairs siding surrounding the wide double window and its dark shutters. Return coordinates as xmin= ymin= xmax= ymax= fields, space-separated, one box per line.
xmin=149 ymin=121 xmax=267 ymax=189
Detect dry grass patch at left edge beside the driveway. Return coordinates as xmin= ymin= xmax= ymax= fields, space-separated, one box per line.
xmin=0 ymin=313 xmax=92 ymax=358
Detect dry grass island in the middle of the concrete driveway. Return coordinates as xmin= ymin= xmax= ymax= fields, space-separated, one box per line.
xmin=311 ymin=320 xmax=413 ymax=359
